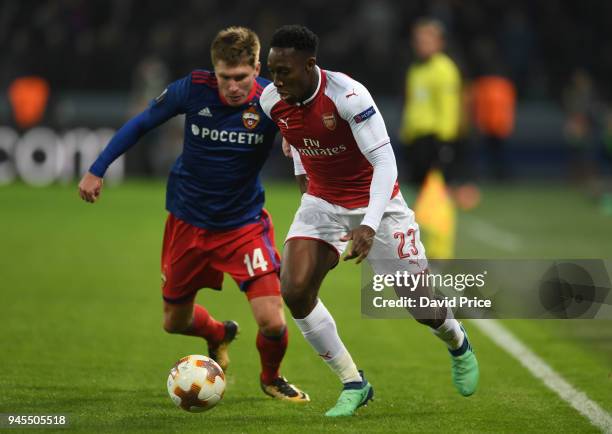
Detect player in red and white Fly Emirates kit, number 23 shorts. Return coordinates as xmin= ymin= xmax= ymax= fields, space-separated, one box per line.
xmin=260 ymin=25 xmax=479 ymax=416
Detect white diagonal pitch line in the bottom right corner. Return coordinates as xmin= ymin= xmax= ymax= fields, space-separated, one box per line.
xmin=471 ymin=319 xmax=612 ymax=434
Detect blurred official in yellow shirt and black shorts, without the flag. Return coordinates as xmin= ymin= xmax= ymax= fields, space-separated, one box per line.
xmin=400 ymin=18 xmax=461 ymax=189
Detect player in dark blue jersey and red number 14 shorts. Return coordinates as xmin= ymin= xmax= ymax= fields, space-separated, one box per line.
xmin=79 ymin=27 xmax=309 ymax=402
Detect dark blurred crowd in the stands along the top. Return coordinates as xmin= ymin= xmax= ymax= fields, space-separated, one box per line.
xmin=0 ymin=0 xmax=612 ymax=103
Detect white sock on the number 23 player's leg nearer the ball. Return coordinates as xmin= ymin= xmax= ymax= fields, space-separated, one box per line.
xmin=294 ymin=300 xmax=361 ymax=383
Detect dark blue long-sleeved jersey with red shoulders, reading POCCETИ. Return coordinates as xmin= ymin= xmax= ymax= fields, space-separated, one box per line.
xmin=90 ymin=70 xmax=278 ymax=229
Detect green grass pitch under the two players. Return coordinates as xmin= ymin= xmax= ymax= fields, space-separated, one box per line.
xmin=0 ymin=181 xmax=612 ymax=433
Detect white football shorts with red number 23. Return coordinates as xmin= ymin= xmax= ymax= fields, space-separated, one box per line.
xmin=285 ymin=193 xmax=427 ymax=274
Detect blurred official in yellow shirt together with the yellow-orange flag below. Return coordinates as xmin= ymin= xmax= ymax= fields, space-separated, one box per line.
xmin=400 ymin=18 xmax=461 ymax=259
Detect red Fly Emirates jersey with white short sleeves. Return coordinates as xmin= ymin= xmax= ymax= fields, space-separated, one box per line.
xmin=260 ymin=68 xmax=399 ymax=209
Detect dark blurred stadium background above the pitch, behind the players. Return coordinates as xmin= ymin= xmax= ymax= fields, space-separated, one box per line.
xmin=0 ymin=0 xmax=612 ymax=182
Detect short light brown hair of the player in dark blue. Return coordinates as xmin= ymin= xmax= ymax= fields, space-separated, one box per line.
xmin=210 ymin=26 xmax=261 ymax=67
